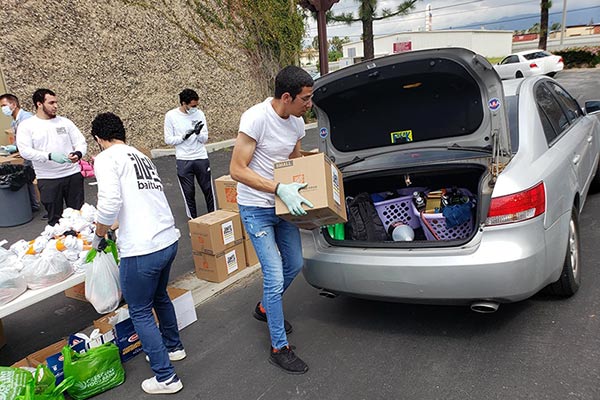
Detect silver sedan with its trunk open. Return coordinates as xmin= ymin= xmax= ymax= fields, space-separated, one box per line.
xmin=302 ymin=48 xmax=600 ymax=312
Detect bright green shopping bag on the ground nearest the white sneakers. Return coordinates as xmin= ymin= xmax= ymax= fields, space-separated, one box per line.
xmin=62 ymin=343 xmax=125 ymax=400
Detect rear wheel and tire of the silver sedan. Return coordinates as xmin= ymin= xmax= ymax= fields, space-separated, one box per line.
xmin=548 ymin=208 xmax=581 ymax=297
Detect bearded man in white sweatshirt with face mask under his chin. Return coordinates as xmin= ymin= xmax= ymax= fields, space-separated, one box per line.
xmin=17 ymin=89 xmax=87 ymax=226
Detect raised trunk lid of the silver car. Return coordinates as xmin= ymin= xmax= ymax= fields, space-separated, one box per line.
xmin=313 ymin=48 xmax=511 ymax=180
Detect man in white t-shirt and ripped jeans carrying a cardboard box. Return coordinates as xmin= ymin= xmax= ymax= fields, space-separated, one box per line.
xmin=229 ymin=66 xmax=314 ymax=374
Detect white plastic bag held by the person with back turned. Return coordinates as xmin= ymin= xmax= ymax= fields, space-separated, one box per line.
xmin=85 ymin=251 xmax=121 ymax=314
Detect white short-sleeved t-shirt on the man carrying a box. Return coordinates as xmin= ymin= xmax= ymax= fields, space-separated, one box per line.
xmin=237 ymin=97 xmax=305 ymax=207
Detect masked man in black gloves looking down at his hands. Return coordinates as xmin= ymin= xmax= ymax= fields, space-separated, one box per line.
xmin=164 ymin=89 xmax=215 ymax=219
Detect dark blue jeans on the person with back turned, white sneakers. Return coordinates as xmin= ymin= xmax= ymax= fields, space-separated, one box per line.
xmin=119 ymin=242 xmax=183 ymax=382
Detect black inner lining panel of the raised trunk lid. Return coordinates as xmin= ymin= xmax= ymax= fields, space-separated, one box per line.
xmin=313 ymin=61 xmax=484 ymax=152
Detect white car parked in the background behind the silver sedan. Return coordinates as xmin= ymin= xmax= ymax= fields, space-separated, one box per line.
xmin=494 ymin=50 xmax=565 ymax=79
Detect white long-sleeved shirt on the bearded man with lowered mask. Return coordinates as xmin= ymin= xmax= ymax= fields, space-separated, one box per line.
xmin=17 ymin=115 xmax=87 ymax=179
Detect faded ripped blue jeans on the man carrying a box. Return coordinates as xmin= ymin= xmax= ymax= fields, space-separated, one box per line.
xmin=239 ymin=205 xmax=304 ymax=349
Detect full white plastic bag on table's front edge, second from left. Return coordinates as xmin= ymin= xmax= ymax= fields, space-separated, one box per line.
xmin=22 ymin=251 xmax=73 ymax=290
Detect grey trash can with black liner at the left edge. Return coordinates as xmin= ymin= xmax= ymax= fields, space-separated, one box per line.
xmin=0 ymin=164 xmax=35 ymax=227
